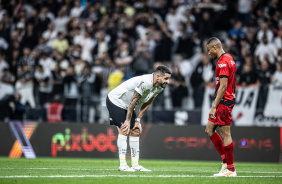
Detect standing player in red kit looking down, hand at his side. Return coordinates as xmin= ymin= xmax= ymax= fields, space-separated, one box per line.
xmin=205 ymin=37 xmax=237 ymax=176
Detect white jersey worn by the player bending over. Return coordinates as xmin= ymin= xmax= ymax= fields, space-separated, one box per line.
xmin=108 ymin=74 xmax=163 ymax=110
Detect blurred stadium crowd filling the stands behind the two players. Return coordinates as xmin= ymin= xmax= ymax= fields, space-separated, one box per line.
xmin=0 ymin=0 xmax=282 ymax=122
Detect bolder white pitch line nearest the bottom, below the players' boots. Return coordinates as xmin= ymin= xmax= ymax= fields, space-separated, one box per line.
xmin=0 ymin=175 xmax=282 ymax=178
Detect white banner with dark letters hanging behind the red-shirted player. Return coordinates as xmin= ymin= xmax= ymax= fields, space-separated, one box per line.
xmin=202 ymin=86 xmax=259 ymax=126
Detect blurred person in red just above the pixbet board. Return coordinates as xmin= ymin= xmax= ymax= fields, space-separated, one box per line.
xmin=47 ymin=95 xmax=64 ymax=123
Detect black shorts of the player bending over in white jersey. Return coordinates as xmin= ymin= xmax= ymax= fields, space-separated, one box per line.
xmin=106 ymin=96 xmax=136 ymax=129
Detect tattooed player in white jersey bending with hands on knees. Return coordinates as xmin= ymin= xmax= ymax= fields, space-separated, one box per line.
xmin=106 ymin=65 xmax=171 ymax=171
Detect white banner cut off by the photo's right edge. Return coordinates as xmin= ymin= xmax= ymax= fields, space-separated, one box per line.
xmin=263 ymin=85 xmax=282 ymax=118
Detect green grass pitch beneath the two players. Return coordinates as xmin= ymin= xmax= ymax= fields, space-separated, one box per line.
xmin=0 ymin=157 xmax=282 ymax=184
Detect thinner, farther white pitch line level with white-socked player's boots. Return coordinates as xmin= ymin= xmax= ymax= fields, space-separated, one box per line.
xmin=0 ymin=167 xmax=282 ymax=174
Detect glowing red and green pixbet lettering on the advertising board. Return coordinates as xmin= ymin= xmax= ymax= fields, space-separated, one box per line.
xmin=51 ymin=127 xmax=117 ymax=157
